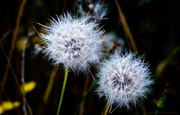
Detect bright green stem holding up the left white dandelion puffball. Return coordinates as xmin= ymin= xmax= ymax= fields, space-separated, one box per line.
xmin=56 ymin=67 xmax=68 ymax=115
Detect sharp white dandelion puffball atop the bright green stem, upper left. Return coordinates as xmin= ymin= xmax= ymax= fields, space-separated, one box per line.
xmin=40 ymin=13 xmax=103 ymax=71
